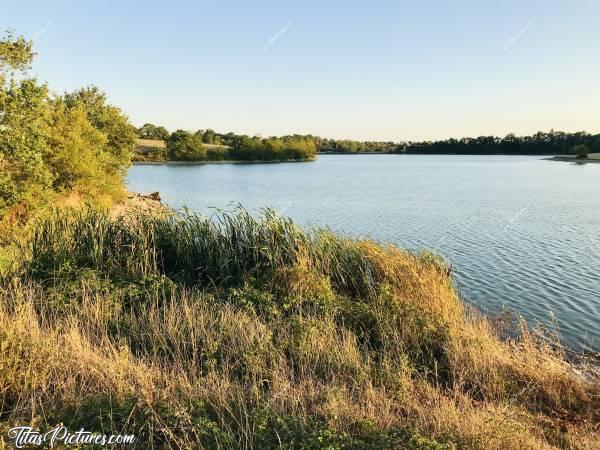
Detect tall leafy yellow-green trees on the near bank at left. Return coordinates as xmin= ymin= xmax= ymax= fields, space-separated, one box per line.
xmin=0 ymin=33 xmax=136 ymax=229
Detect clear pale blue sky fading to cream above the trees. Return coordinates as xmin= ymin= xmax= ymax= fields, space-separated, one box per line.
xmin=0 ymin=0 xmax=600 ymax=141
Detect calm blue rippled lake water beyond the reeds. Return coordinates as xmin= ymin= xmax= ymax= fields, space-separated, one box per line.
xmin=128 ymin=155 xmax=600 ymax=351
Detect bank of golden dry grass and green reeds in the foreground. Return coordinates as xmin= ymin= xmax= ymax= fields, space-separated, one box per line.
xmin=0 ymin=210 xmax=600 ymax=449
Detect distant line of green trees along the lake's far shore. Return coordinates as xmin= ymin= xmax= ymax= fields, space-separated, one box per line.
xmin=139 ymin=124 xmax=600 ymax=160
